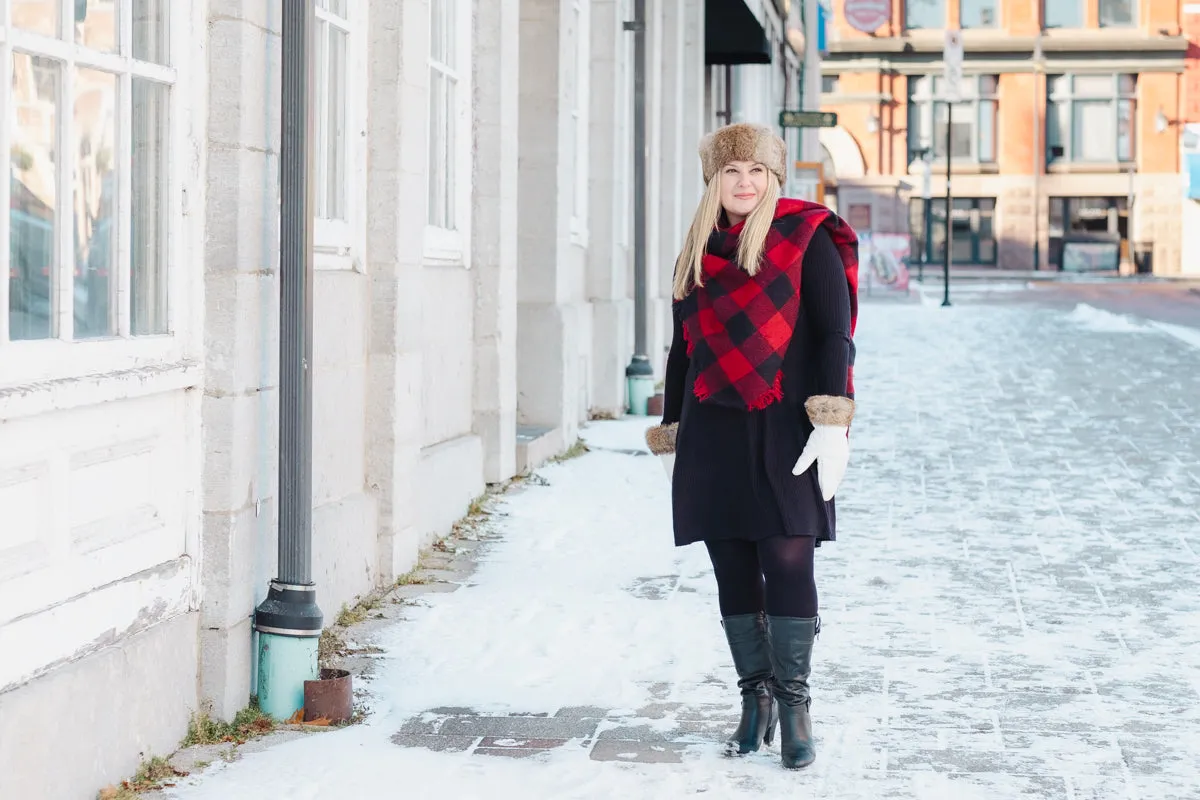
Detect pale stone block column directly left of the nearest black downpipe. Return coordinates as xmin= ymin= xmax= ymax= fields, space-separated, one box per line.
xmin=199 ymin=2 xmax=281 ymax=720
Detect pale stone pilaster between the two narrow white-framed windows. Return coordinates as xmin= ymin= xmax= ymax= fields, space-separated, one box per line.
xmin=367 ymin=0 xmax=430 ymax=583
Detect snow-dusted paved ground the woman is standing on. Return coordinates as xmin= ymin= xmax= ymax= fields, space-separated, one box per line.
xmin=167 ymin=298 xmax=1200 ymax=800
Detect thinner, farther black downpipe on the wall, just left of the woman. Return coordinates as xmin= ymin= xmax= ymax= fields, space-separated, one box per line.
xmin=625 ymin=0 xmax=654 ymax=398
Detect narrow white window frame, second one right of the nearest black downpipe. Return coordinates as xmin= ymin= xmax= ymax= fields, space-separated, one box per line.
xmin=421 ymin=0 xmax=473 ymax=269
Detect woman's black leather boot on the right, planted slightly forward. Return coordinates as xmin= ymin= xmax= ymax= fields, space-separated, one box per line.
xmin=767 ymin=616 xmax=821 ymax=770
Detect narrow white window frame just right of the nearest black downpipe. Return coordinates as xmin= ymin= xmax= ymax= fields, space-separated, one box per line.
xmin=313 ymin=0 xmax=368 ymax=272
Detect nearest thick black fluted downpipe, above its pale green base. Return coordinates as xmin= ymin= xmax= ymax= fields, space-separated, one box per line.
xmin=254 ymin=0 xmax=323 ymax=637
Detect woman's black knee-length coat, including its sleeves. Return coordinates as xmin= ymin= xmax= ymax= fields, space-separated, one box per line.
xmin=662 ymin=229 xmax=853 ymax=546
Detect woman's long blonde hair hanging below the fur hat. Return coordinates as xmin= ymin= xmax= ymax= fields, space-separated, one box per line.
xmin=672 ymin=172 xmax=782 ymax=300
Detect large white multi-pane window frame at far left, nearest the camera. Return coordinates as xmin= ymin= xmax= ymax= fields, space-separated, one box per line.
xmin=0 ymin=0 xmax=190 ymax=390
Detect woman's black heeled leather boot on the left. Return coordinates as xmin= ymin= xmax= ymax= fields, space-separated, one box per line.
xmin=721 ymin=614 xmax=779 ymax=756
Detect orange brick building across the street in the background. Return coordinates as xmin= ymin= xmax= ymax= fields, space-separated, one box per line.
xmin=821 ymin=0 xmax=1194 ymax=275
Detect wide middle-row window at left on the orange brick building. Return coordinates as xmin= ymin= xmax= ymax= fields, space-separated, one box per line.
xmin=908 ymin=76 xmax=998 ymax=163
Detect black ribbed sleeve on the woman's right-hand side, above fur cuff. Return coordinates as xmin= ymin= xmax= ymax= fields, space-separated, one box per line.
xmin=800 ymin=228 xmax=854 ymax=397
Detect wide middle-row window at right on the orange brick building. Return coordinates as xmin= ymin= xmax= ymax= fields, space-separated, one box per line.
xmin=1046 ymin=74 xmax=1138 ymax=163
